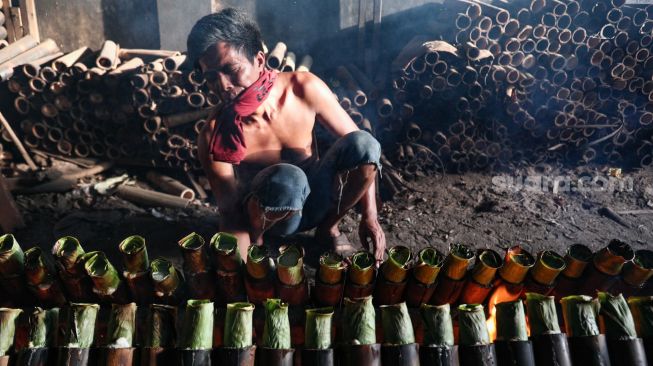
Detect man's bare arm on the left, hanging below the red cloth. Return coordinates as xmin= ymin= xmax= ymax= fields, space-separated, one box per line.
xmin=197 ymin=119 xmax=251 ymax=260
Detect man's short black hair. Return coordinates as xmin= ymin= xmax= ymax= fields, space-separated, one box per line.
xmin=186 ymin=8 xmax=263 ymax=66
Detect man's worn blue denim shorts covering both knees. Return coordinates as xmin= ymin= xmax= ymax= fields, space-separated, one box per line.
xmin=245 ymin=131 xmax=381 ymax=236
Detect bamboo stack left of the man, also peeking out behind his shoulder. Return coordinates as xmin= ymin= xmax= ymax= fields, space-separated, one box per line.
xmin=0 ymin=36 xmax=312 ymax=170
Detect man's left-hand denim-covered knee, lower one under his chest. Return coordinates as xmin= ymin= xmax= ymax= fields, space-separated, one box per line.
xmin=252 ymin=164 xmax=310 ymax=212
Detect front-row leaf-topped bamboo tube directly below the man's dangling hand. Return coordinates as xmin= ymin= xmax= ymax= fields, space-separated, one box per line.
xmin=341 ymin=296 xmax=381 ymax=366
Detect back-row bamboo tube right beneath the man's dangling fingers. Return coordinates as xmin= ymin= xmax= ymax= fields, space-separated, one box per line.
xmin=344 ymin=250 xmax=376 ymax=299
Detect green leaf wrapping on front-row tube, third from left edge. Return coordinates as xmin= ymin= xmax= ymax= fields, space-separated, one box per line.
xmin=64 ymin=303 xmax=100 ymax=348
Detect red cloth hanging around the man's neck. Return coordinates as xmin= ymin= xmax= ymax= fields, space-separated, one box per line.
xmin=210 ymin=68 xmax=277 ymax=164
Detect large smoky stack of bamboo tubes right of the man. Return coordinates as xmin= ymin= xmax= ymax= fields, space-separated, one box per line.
xmin=335 ymin=0 xmax=653 ymax=182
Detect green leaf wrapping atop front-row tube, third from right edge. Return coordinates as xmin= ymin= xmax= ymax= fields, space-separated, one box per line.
xmin=560 ymin=295 xmax=600 ymax=337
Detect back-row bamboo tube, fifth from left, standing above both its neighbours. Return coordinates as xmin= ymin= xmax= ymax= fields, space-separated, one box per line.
xmin=118 ymin=235 xmax=154 ymax=305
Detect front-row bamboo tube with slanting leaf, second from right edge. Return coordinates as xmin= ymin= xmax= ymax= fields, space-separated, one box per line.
xmin=598 ymin=292 xmax=648 ymax=366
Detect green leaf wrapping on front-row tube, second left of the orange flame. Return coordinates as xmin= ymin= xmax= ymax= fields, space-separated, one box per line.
xmin=419 ymin=304 xmax=454 ymax=346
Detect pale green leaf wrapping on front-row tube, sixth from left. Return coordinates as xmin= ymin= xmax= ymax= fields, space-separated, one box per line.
xmin=180 ymin=300 xmax=213 ymax=350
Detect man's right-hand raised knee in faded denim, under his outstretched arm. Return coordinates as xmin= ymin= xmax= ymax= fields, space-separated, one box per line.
xmin=339 ymin=130 xmax=381 ymax=169
